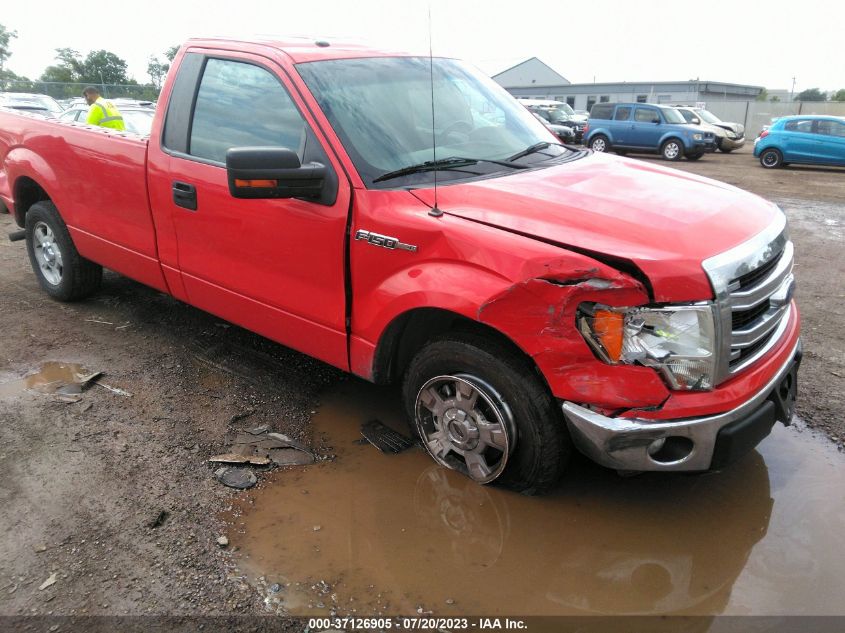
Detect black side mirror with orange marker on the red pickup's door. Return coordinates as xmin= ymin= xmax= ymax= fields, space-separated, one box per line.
xmin=226 ymin=147 xmax=326 ymax=198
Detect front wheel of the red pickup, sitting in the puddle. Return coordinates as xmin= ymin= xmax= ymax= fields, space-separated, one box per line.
xmin=402 ymin=334 xmax=572 ymax=494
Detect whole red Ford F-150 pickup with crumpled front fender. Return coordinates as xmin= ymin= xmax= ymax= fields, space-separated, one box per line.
xmin=0 ymin=39 xmax=801 ymax=493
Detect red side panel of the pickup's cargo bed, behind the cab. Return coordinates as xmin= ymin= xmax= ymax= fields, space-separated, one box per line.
xmin=0 ymin=108 xmax=167 ymax=291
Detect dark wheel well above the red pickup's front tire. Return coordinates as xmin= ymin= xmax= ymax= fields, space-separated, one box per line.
xmin=373 ymin=308 xmax=548 ymax=389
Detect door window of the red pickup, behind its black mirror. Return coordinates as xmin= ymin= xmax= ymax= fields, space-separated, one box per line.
xmin=188 ymin=59 xmax=305 ymax=163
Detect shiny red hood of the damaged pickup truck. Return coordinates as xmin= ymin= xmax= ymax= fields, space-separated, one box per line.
xmin=413 ymin=153 xmax=780 ymax=301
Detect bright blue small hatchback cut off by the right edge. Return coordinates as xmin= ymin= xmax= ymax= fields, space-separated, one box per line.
xmin=754 ymin=115 xmax=845 ymax=169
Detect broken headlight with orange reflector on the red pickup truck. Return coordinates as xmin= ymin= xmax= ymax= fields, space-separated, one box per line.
xmin=578 ymin=304 xmax=716 ymax=391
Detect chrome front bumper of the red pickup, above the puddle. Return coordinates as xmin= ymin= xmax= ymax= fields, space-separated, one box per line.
xmin=563 ymin=341 xmax=801 ymax=471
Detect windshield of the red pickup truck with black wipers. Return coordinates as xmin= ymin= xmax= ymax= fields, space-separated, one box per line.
xmin=297 ymin=57 xmax=568 ymax=188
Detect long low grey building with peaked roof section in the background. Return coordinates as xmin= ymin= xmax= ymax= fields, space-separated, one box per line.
xmin=493 ymin=57 xmax=763 ymax=111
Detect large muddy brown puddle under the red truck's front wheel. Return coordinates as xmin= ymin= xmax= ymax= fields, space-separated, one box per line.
xmin=228 ymin=381 xmax=845 ymax=615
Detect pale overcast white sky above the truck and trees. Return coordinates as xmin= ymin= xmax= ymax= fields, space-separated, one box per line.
xmin=0 ymin=0 xmax=845 ymax=92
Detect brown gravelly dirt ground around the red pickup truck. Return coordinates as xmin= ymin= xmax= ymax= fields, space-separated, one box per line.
xmin=0 ymin=143 xmax=845 ymax=616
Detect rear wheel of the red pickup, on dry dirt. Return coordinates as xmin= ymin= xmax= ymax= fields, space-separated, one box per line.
xmin=25 ymin=201 xmax=103 ymax=301
